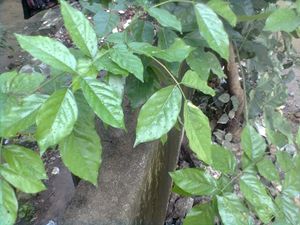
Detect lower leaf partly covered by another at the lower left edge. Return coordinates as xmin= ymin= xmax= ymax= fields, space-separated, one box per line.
xmin=0 ymin=164 xmax=46 ymax=194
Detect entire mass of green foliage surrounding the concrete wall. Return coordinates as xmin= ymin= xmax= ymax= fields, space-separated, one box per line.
xmin=0 ymin=0 xmax=300 ymax=225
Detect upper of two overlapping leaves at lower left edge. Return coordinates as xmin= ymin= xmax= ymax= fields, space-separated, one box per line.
xmin=3 ymin=145 xmax=47 ymax=179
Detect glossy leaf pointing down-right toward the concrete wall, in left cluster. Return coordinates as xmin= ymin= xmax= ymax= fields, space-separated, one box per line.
xmin=81 ymin=77 xmax=125 ymax=128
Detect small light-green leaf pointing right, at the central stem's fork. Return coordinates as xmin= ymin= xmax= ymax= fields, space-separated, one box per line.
xmin=181 ymin=70 xmax=215 ymax=96
